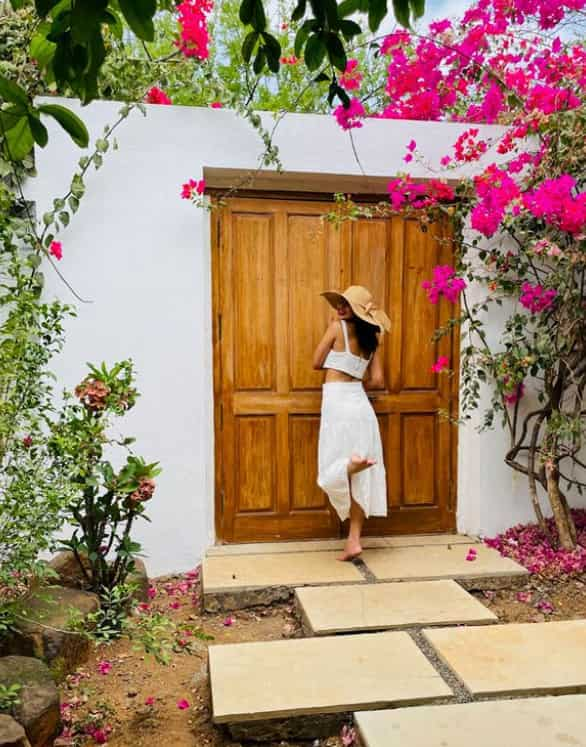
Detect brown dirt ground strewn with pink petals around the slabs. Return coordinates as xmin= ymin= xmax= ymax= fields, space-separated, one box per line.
xmin=61 ymin=576 xmax=586 ymax=747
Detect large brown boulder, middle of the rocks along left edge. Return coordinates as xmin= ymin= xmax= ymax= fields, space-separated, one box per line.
xmin=0 ymin=586 xmax=100 ymax=680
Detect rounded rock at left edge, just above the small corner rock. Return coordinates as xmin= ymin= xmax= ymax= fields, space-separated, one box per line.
xmin=0 ymin=656 xmax=61 ymax=747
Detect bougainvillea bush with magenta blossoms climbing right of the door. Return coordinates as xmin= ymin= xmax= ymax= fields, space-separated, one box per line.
xmin=314 ymin=0 xmax=586 ymax=548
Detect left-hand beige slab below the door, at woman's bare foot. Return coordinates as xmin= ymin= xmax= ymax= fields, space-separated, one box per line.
xmin=202 ymin=552 xmax=364 ymax=593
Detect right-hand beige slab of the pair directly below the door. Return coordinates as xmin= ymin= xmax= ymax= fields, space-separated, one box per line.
xmin=361 ymin=544 xmax=528 ymax=586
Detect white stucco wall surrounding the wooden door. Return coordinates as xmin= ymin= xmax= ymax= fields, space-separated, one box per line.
xmin=29 ymin=99 xmax=584 ymax=575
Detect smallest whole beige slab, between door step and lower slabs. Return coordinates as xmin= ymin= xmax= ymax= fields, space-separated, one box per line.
xmin=295 ymin=581 xmax=498 ymax=635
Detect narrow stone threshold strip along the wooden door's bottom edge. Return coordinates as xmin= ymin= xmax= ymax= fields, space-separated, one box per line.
xmin=206 ymin=534 xmax=478 ymax=558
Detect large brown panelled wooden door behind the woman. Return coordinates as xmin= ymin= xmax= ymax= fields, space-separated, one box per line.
xmin=213 ymin=198 xmax=456 ymax=542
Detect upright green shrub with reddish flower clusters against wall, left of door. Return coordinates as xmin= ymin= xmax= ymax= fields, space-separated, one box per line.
xmin=50 ymin=360 xmax=160 ymax=601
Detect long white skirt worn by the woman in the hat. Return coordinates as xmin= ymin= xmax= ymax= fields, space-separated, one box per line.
xmin=317 ymin=381 xmax=387 ymax=521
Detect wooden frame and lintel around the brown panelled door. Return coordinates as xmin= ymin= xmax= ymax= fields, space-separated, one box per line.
xmin=208 ymin=167 xmax=460 ymax=543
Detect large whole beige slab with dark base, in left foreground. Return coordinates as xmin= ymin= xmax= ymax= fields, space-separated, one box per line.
xmin=209 ymin=633 xmax=451 ymax=741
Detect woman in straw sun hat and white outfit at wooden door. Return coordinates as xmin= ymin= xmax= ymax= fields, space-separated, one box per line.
xmin=313 ymin=285 xmax=390 ymax=560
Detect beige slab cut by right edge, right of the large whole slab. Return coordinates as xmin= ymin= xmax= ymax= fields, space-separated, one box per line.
xmin=424 ymin=620 xmax=586 ymax=700
